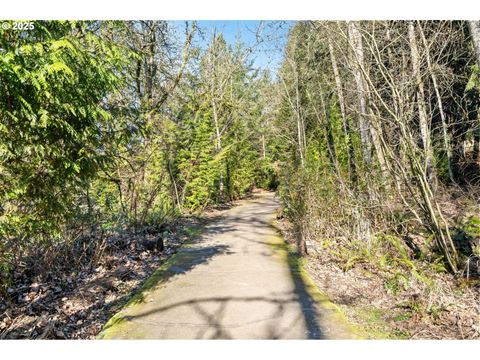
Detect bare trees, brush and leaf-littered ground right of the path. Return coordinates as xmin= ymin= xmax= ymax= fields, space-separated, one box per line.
xmin=275 ymin=21 xmax=480 ymax=338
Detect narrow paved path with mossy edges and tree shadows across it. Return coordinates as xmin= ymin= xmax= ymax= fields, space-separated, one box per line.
xmin=99 ymin=192 xmax=352 ymax=339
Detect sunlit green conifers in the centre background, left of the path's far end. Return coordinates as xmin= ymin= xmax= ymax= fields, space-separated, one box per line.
xmin=165 ymin=36 xmax=275 ymax=212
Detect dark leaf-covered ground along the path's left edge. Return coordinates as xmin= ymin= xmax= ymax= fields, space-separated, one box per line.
xmin=0 ymin=214 xmax=223 ymax=339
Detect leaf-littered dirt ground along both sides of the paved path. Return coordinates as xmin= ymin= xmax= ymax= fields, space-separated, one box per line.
xmin=0 ymin=190 xmax=480 ymax=339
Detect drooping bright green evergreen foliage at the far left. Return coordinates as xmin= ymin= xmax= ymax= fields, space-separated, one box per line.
xmin=0 ymin=22 xmax=124 ymax=243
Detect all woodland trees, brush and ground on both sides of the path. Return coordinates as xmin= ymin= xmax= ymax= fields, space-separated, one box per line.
xmin=0 ymin=21 xmax=480 ymax=338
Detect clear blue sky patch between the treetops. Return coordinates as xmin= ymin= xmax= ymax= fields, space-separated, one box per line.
xmin=172 ymin=20 xmax=293 ymax=74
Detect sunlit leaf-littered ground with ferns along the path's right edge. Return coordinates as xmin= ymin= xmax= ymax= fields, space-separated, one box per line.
xmin=278 ymin=219 xmax=480 ymax=339
